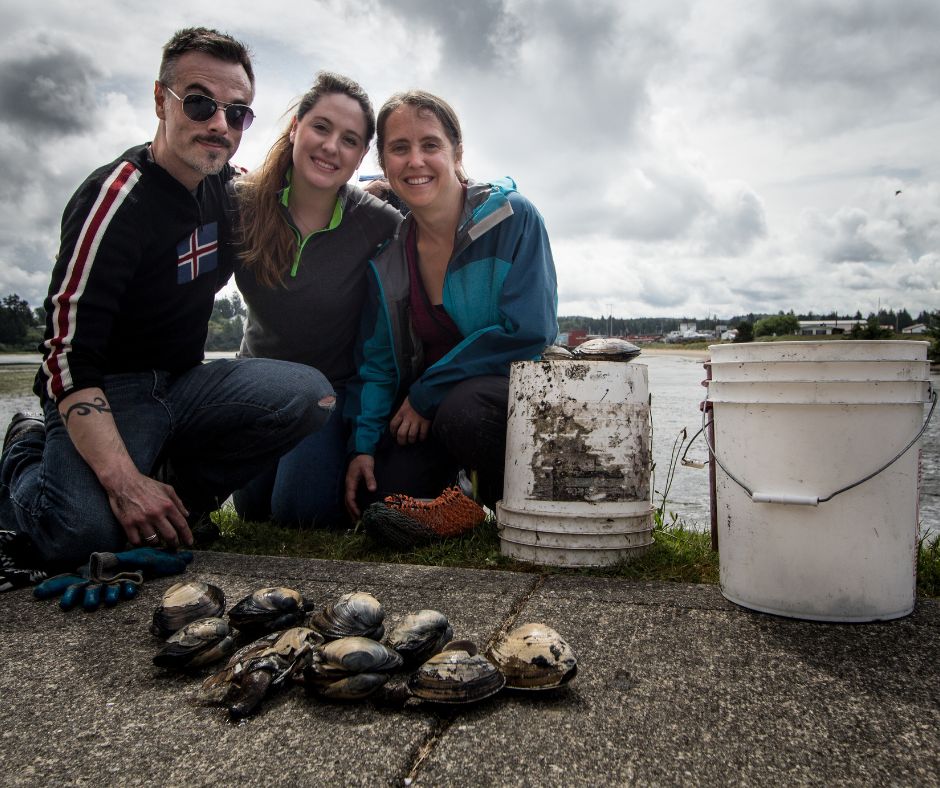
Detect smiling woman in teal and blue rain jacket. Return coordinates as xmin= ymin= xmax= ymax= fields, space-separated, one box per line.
xmin=345 ymin=91 xmax=558 ymax=516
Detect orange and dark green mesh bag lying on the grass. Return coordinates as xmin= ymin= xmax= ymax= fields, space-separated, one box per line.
xmin=362 ymin=487 xmax=486 ymax=547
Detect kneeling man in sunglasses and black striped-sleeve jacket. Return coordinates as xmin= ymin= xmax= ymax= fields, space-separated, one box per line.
xmin=0 ymin=28 xmax=335 ymax=589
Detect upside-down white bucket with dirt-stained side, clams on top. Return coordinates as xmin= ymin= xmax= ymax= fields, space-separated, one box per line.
xmin=496 ymin=360 xmax=653 ymax=566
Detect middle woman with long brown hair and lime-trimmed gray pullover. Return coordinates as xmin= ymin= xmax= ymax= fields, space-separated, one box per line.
xmin=234 ymin=72 xmax=401 ymax=525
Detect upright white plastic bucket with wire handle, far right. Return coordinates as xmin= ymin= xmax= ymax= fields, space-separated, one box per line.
xmin=708 ymin=340 xmax=930 ymax=621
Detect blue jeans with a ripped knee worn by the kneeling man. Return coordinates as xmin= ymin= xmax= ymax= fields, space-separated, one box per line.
xmin=0 ymin=359 xmax=333 ymax=570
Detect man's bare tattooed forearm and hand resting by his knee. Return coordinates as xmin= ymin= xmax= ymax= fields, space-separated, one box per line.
xmin=59 ymin=388 xmax=193 ymax=548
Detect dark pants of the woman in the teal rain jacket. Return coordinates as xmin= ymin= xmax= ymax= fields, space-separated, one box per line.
xmin=358 ymin=375 xmax=509 ymax=509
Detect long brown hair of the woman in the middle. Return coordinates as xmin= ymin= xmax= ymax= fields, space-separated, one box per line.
xmin=236 ymin=71 xmax=375 ymax=287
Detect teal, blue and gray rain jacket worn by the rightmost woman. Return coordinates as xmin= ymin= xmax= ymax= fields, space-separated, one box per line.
xmin=344 ymin=178 xmax=558 ymax=455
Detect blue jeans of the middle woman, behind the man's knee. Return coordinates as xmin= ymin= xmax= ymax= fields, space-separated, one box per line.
xmin=232 ymin=387 xmax=349 ymax=527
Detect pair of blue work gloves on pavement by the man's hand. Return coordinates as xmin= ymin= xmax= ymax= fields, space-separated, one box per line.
xmin=33 ymin=547 xmax=193 ymax=611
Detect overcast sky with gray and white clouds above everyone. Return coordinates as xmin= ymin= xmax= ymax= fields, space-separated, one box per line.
xmin=0 ymin=0 xmax=940 ymax=318
